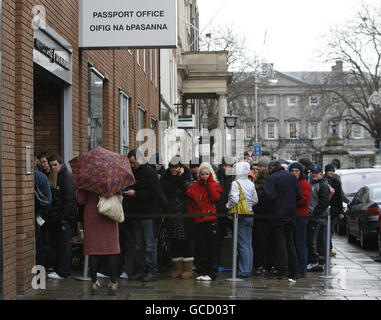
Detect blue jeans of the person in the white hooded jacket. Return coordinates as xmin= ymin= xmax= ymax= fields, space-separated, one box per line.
xmin=238 ymin=218 xmax=254 ymax=277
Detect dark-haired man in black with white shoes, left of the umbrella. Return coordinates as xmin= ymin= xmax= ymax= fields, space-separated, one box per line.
xmin=48 ymin=155 xmax=77 ymax=279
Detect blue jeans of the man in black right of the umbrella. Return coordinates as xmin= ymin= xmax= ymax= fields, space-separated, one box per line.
xmin=133 ymin=219 xmax=158 ymax=277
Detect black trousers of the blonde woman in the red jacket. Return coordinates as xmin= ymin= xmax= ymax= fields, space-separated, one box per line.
xmin=194 ymin=221 xmax=217 ymax=279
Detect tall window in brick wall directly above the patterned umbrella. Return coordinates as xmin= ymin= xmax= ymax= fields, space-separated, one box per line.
xmin=87 ymin=68 xmax=105 ymax=150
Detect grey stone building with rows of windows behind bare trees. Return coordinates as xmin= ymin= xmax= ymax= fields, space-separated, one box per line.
xmin=229 ymin=62 xmax=380 ymax=168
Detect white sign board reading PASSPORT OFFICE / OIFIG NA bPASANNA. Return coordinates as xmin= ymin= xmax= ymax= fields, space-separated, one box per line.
xmin=79 ymin=0 xmax=177 ymax=48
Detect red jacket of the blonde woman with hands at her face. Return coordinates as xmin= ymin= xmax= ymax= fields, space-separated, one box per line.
xmin=186 ymin=174 xmax=223 ymax=223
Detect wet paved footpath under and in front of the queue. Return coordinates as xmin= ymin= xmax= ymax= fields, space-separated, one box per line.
xmin=23 ymin=236 xmax=381 ymax=301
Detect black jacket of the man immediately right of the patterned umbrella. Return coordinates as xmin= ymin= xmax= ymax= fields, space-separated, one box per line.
xmin=127 ymin=164 xmax=167 ymax=219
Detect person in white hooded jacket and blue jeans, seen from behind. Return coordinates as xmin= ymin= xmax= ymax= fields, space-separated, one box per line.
xmin=226 ymin=162 xmax=258 ymax=277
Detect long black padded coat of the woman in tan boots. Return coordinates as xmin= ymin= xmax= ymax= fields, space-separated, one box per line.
xmin=160 ymin=167 xmax=194 ymax=240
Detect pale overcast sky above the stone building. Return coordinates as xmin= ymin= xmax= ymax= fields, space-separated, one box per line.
xmin=197 ymin=0 xmax=370 ymax=71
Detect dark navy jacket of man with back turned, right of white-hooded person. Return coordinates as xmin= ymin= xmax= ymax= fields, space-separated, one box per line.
xmin=263 ymin=167 xmax=302 ymax=227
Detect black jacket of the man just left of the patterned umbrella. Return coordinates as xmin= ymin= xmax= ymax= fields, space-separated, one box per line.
xmin=49 ymin=164 xmax=77 ymax=222
